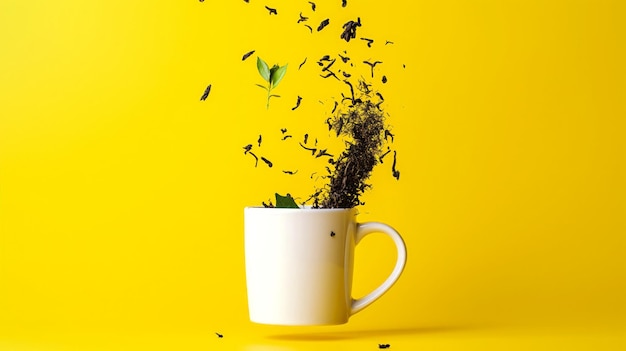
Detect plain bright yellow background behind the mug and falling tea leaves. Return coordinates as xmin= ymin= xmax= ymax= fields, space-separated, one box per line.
xmin=0 ymin=0 xmax=626 ymax=351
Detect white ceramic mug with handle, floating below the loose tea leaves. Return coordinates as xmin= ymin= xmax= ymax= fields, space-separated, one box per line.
xmin=244 ymin=207 xmax=406 ymax=325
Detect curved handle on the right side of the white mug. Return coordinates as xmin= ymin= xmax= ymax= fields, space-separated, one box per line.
xmin=350 ymin=222 xmax=406 ymax=315
